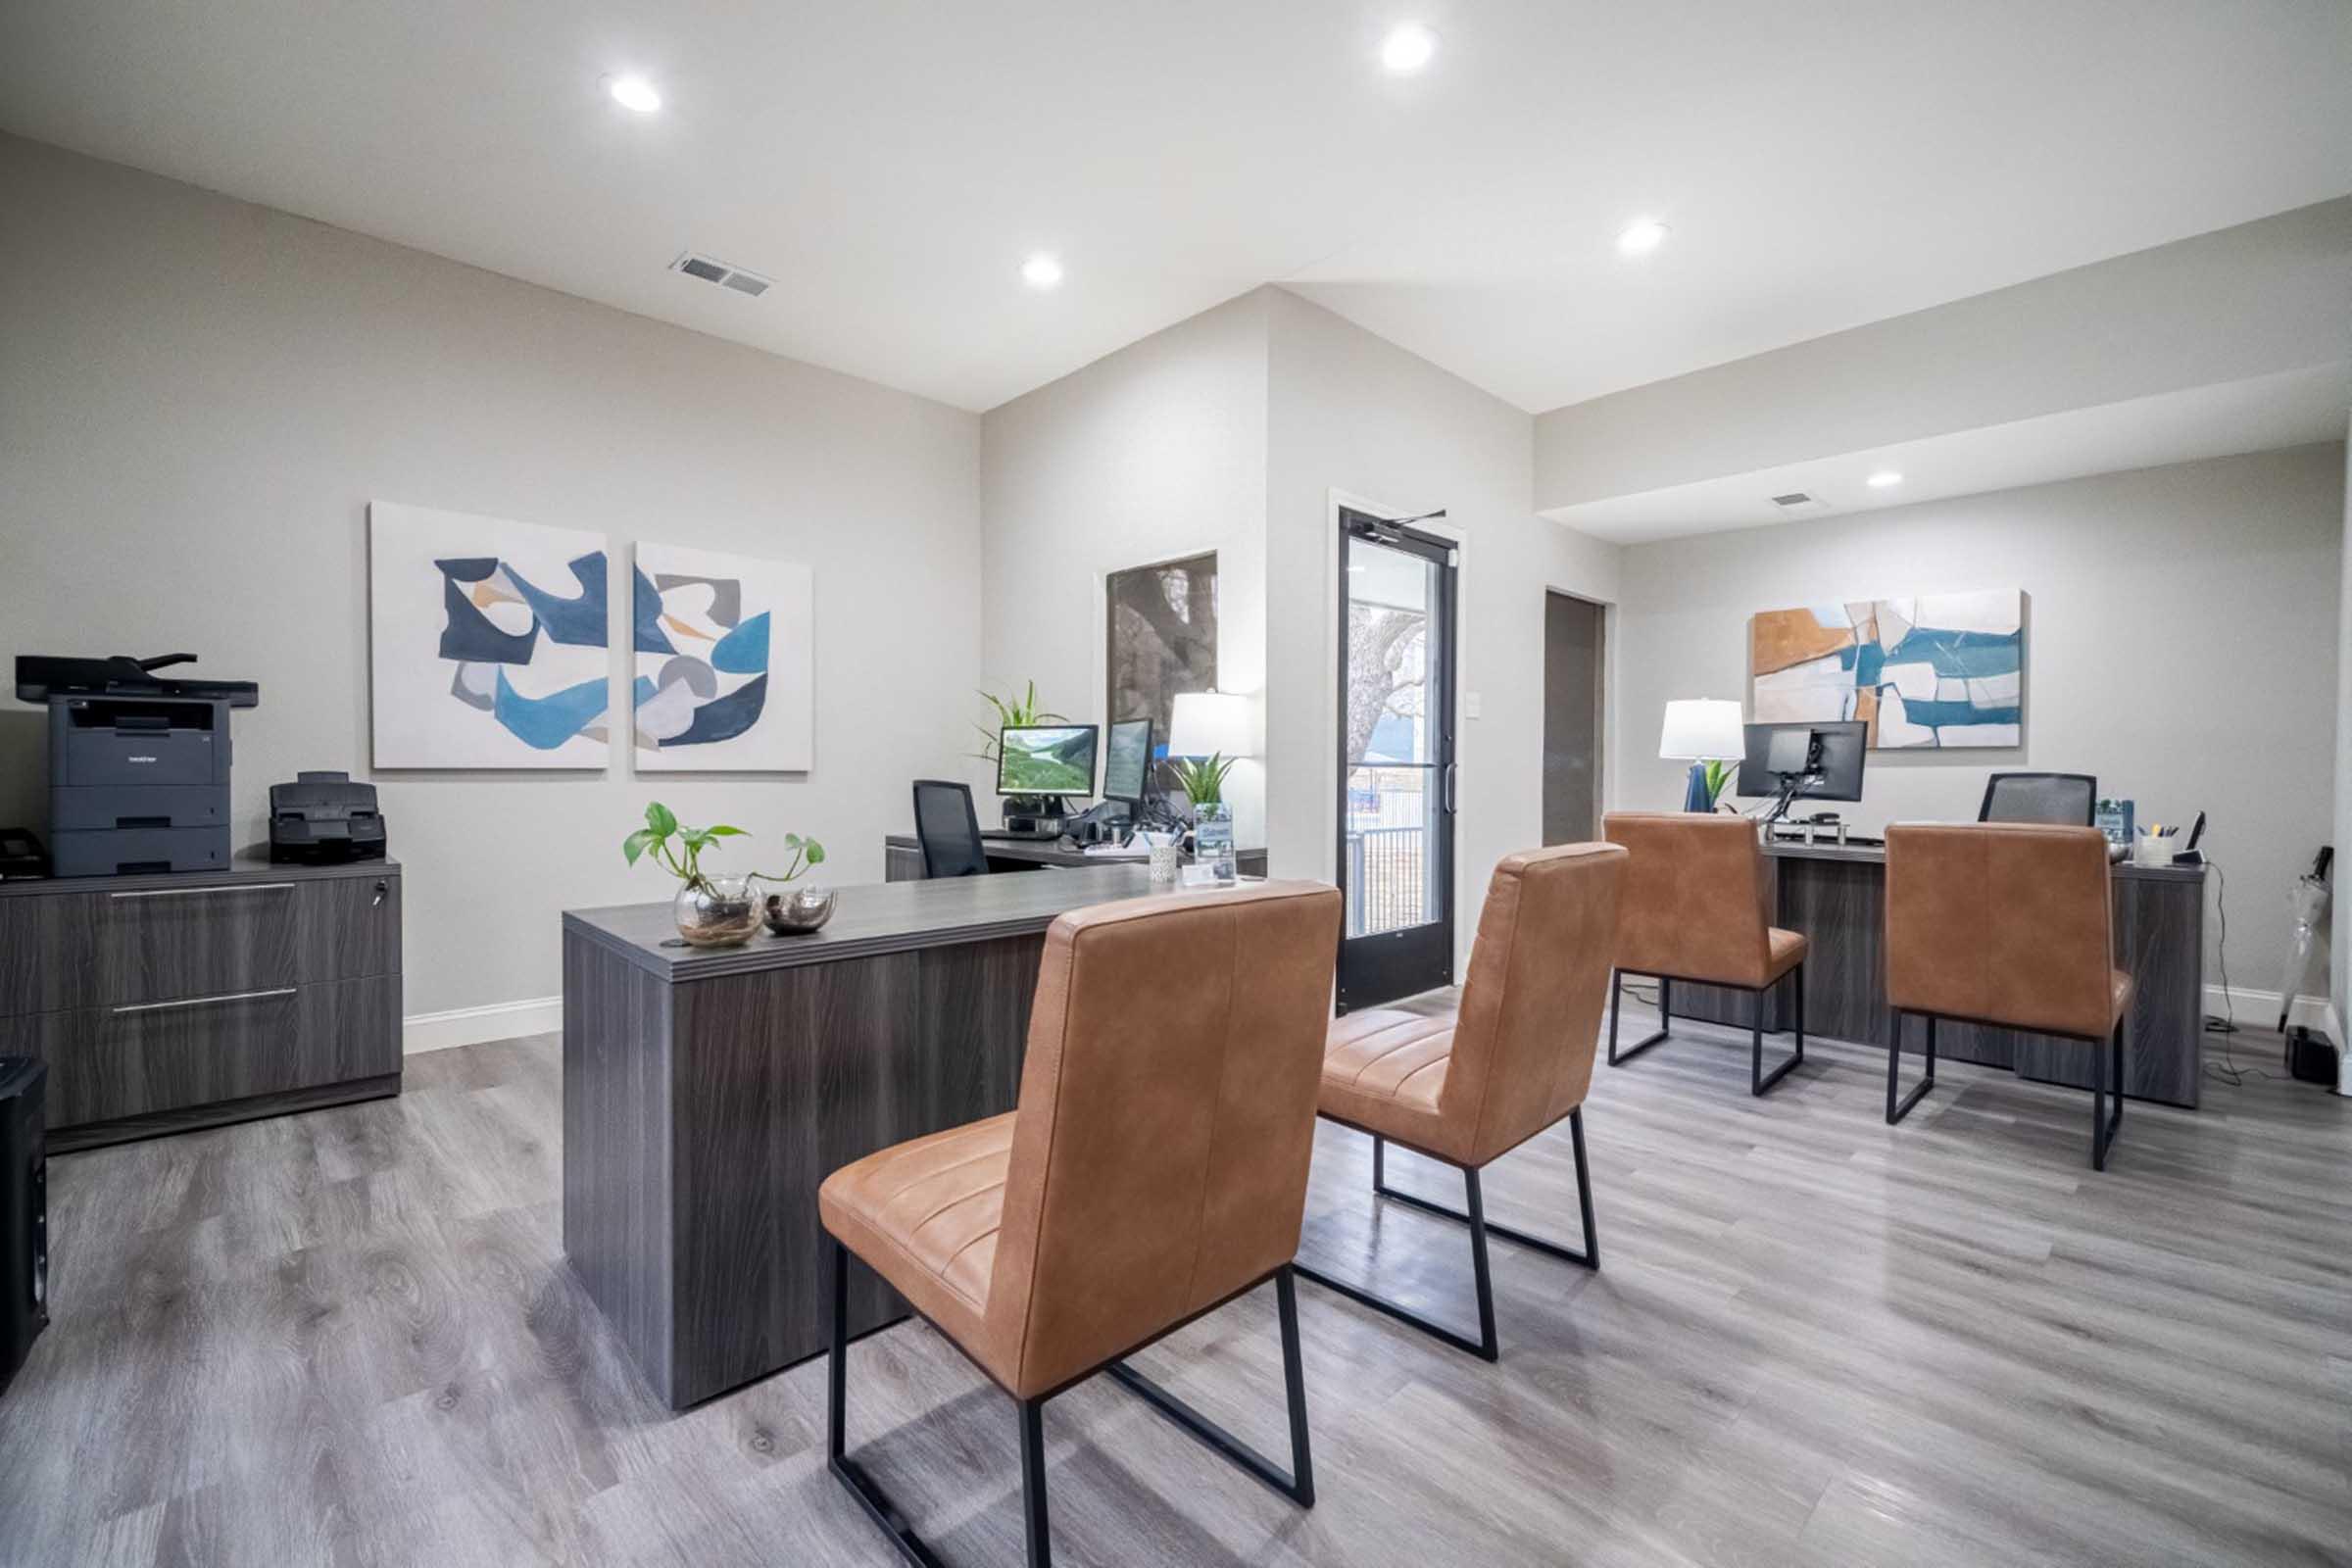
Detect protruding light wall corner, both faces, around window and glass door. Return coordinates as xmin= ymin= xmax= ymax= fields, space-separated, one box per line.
xmin=981 ymin=287 xmax=1618 ymax=968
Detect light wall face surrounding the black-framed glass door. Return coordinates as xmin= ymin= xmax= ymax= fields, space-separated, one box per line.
xmin=1265 ymin=289 xmax=1621 ymax=953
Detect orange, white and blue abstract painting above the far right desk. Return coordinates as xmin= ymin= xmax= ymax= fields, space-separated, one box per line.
xmin=1747 ymin=588 xmax=2025 ymax=750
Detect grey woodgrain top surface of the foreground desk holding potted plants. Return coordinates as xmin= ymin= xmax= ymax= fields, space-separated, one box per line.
xmin=564 ymin=862 xmax=1152 ymax=980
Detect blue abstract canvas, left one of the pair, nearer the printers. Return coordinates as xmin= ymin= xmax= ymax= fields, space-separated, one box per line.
xmin=367 ymin=501 xmax=612 ymax=768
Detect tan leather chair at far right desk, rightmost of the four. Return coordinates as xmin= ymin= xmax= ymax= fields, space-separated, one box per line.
xmin=1886 ymin=823 xmax=2131 ymax=1171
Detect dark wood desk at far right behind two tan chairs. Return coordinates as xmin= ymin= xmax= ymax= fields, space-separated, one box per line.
xmin=1675 ymin=844 xmax=2204 ymax=1107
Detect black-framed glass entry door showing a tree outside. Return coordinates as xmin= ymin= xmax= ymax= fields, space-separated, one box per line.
xmin=1339 ymin=508 xmax=1453 ymax=1013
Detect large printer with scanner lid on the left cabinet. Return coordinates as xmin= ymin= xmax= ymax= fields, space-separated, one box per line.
xmin=17 ymin=654 xmax=261 ymax=877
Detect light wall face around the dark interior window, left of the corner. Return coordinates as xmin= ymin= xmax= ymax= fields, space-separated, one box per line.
xmin=966 ymin=294 xmax=1265 ymax=849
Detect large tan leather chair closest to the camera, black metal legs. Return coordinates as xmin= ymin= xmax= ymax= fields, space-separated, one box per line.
xmin=816 ymin=882 xmax=1341 ymax=1568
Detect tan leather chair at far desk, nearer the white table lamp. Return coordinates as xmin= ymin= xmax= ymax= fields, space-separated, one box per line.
xmin=1601 ymin=811 xmax=1806 ymax=1096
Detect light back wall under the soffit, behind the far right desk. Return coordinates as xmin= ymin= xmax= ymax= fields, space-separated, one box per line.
xmin=1613 ymin=442 xmax=2345 ymax=990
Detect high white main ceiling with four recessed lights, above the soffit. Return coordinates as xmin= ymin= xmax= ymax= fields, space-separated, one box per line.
xmin=0 ymin=0 xmax=2352 ymax=412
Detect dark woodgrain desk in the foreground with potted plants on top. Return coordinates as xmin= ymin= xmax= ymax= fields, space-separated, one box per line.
xmin=564 ymin=865 xmax=1181 ymax=1410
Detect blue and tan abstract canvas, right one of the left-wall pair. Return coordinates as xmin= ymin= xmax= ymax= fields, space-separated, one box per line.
xmin=630 ymin=543 xmax=816 ymax=773
